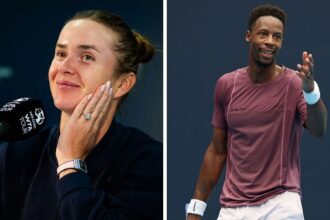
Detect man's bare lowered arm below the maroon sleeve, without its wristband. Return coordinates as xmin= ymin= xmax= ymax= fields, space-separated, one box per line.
xmin=187 ymin=128 xmax=227 ymax=220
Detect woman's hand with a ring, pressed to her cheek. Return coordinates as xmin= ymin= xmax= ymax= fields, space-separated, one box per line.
xmin=56 ymin=81 xmax=113 ymax=168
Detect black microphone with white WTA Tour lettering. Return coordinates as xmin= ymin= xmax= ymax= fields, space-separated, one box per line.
xmin=0 ymin=97 xmax=46 ymax=142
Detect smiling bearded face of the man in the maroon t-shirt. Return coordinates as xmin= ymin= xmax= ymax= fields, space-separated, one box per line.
xmin=246 ymin=16 xmax=283 ymax=67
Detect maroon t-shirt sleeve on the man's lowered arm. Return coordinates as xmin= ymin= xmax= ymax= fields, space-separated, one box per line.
xmin=212 ymin=78 xmax=227 ymax=130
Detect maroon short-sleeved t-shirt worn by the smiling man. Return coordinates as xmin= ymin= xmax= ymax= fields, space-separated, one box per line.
xmin=212 ymin=67 xmax=307 ymax=207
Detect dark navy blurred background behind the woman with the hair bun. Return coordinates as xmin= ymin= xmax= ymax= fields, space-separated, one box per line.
xmin=0 ymin=0 xmax=163 ymax=141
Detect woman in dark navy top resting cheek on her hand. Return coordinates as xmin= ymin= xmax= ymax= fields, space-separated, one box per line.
xmin=0 ymin=10 xmax=162 ymax=220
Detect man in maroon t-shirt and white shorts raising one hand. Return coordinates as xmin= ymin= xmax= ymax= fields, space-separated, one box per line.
xmin=186 ymin=4 xmax=327 ymax=220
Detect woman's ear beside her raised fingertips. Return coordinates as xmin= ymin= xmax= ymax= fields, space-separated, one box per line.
xmin=113 ymin=72 xmax=136 ymax=98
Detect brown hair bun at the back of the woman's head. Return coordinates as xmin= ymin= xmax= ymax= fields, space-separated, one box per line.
xmin=133 ymin=31 xmax=155 ymax=63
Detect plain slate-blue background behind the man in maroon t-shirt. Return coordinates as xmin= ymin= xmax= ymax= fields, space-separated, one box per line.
xmin=167 ymin=0 xmax=330 ymax=220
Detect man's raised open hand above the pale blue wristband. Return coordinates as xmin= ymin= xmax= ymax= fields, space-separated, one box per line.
xmin=297 ymin=51 xmax=314 ymax=93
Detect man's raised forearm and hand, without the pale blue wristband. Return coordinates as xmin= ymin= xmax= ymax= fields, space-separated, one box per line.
xmin=297 ymin=51 xmax=327 ymax=137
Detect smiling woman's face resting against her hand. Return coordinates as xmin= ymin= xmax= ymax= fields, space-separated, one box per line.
xmin=49 ymin=19 xmax=117 ymax=113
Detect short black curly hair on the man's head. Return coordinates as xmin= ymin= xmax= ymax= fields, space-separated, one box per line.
xmin=249 ymin=4 xmax=286 ymax=31
